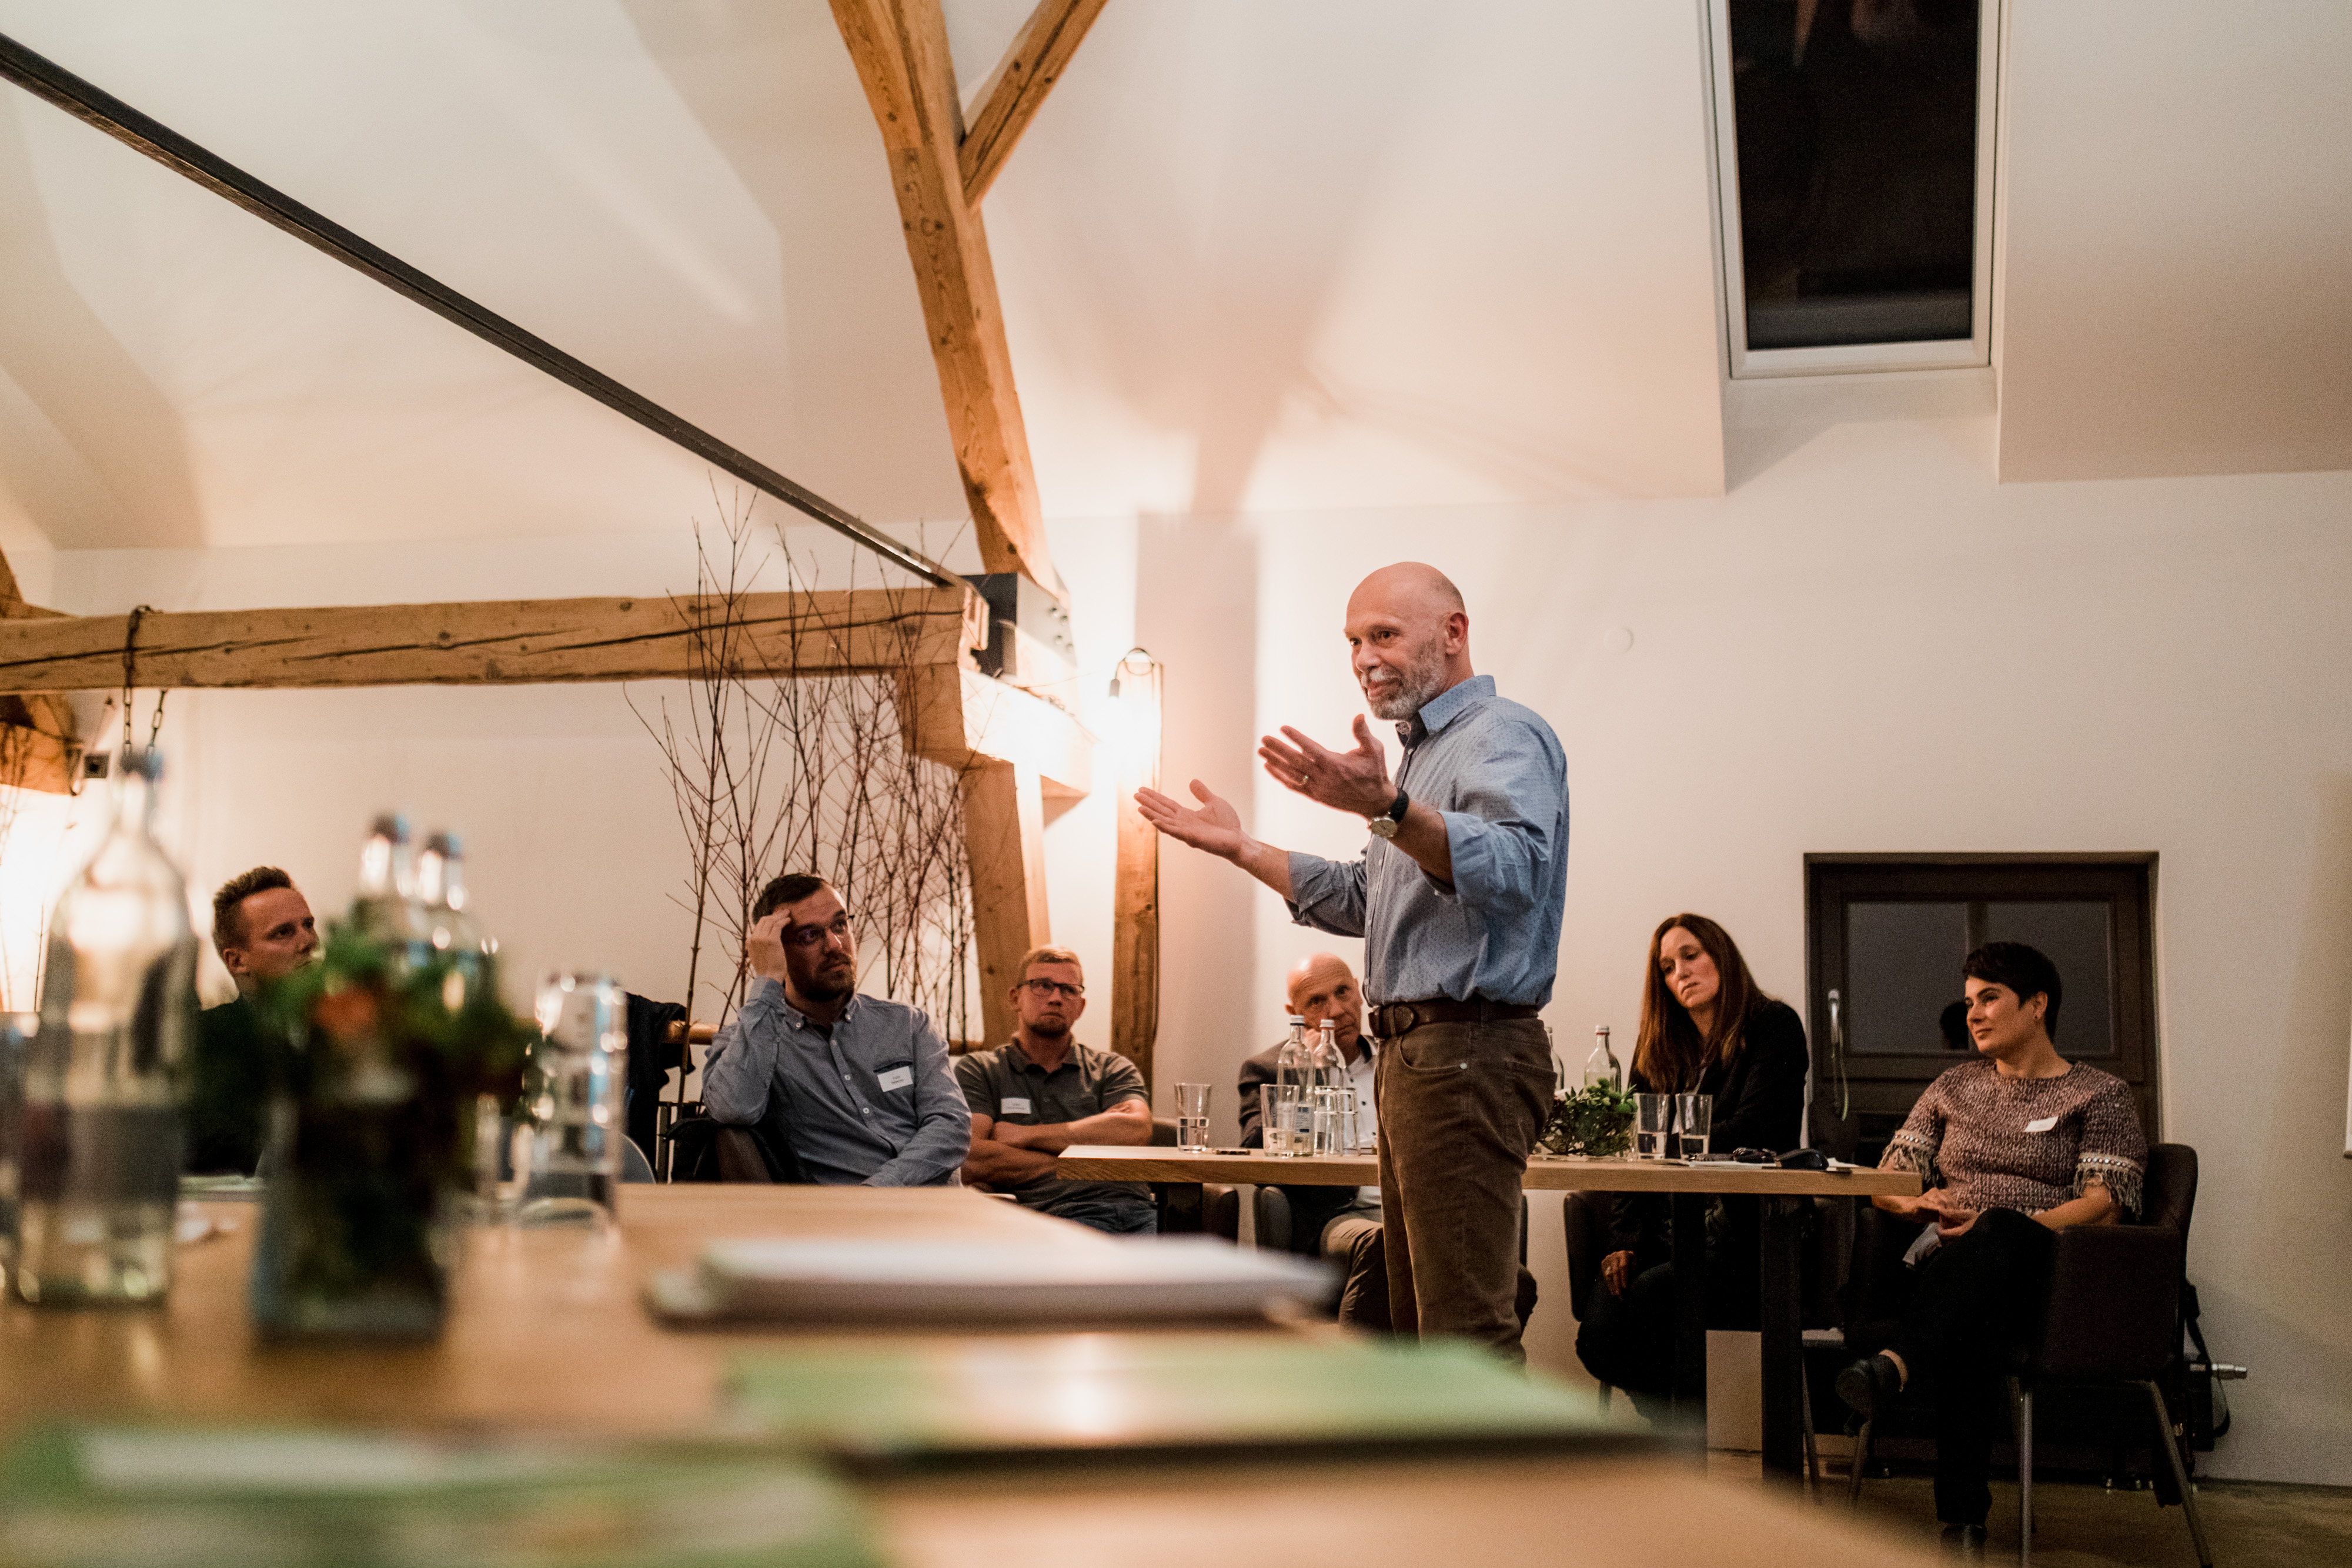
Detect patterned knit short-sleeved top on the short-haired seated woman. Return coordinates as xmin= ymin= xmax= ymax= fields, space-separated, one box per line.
xmin=1879 ymin=1060 xmax=2147 ymax=1215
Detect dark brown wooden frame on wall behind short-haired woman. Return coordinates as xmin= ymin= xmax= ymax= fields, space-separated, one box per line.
xmin=1804 ymin=851 xmax=2164 ymax=1159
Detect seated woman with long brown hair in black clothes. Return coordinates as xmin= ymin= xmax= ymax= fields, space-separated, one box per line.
xmin=1576 ymin=914 xmax=1811 ymax=1408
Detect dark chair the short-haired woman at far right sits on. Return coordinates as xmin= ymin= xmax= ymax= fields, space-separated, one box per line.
xmin=1846 ymin=1142 xmax=2213 ymax=1568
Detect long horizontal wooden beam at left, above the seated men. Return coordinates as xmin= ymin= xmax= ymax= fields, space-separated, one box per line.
xmin=0 ymin=588 xmax=988 ymax=694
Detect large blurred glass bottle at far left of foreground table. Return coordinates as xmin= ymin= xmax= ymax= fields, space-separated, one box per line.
xmin=14 ymin=750 xmax=195 ymax=1305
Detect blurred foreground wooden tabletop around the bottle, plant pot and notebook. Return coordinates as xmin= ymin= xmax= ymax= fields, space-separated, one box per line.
xmin=0 ymin=1185 xmax=1157 ymax=1434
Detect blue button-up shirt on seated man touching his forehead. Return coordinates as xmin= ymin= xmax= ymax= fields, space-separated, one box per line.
xmin=703 ymin=980 xmax=971 ymax=1187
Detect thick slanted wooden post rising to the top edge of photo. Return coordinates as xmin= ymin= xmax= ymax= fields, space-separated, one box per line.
xmin=833 ymin=0 xmax=1061 ymax=597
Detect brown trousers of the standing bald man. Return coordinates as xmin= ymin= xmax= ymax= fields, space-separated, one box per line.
xmin=1376 ymin=1018 xmax=1552 ymax=1359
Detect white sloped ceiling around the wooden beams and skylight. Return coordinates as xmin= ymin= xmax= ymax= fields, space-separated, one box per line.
xmin=0 ymin=0 xmax=2352 ymax=548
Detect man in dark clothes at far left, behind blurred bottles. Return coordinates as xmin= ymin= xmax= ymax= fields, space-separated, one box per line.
xmin=188 ymin=865 xmax=318 ymax=1175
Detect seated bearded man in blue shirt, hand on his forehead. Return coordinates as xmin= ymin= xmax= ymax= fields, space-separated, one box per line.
xmin=703 ymin=874 xmax=971 ymax=1187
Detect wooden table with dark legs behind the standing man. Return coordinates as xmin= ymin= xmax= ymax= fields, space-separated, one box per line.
xmin=1056 ymin=1145 xmax=1919 ymax=1481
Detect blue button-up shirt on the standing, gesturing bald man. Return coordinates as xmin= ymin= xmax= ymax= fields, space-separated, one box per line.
xmin=1291 ymin=675 xmax=1569 ymax=1006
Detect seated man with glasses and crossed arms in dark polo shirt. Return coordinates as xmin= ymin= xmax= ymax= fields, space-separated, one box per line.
xmin=955 ymin=947 xmax=1160 ymax=1236
